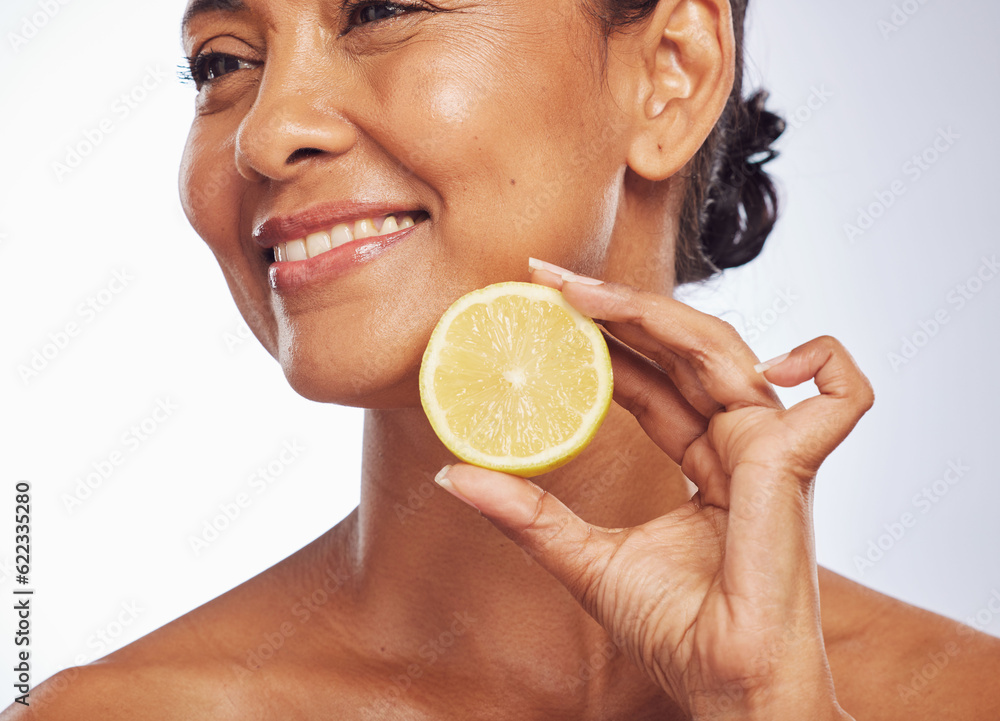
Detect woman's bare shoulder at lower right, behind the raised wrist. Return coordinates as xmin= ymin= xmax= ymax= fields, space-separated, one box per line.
xmin=820 ymin=569 xmax=1000 ymax=721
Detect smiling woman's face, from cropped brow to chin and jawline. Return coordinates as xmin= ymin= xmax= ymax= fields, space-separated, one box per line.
xmin=180 ymin=0 xmax=627 ymax=407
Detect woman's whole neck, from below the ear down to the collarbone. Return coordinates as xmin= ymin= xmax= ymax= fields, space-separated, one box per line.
xmin=328 ymin=173 xmax=694 ymax=721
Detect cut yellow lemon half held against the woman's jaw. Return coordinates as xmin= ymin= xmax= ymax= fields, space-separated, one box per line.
xmin=420 ymin=282 xmax=613 ymax=476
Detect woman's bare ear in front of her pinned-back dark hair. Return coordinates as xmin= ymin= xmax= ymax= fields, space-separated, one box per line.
xmin=609 ymin=0 xmax=736 ymax=180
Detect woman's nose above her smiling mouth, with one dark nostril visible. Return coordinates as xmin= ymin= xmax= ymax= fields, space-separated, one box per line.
xmin=235 ymin=48 xmax=357 ymax=182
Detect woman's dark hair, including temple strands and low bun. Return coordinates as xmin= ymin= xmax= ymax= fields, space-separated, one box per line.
xmin=588 ymin=0 xmax=785 ymax=283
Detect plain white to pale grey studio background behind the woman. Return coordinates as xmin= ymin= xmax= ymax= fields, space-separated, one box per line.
xmin=0 ymin=0 xmax=1000 ymax=692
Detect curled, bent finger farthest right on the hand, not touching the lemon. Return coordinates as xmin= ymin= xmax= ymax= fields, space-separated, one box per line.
xmin=761 ymin=336 xmax=875 ymax=472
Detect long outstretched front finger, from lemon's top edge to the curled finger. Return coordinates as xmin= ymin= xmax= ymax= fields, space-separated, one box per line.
xmin=562 ymin=276 xmax=781 ymax=410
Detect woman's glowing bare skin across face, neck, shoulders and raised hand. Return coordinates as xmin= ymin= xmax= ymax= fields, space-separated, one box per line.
xmin=13 ymin=0 xmax=1000 ymax=721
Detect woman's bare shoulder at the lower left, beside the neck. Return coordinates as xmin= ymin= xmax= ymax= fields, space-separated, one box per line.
xmin=0 ymin=516 xmax=365 ymax=721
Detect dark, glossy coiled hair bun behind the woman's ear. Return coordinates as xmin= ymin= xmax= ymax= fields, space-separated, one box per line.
xmin=699 ymin=90 xmax=785 ymax=270
